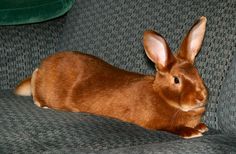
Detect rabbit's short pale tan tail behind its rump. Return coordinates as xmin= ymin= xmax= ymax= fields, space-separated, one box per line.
xmin=15 ymin=77 xmax=32 ymax=96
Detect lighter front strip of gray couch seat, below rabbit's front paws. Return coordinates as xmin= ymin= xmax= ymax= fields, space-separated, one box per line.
xmin=97 ymin=134 xmax=236 ymax=154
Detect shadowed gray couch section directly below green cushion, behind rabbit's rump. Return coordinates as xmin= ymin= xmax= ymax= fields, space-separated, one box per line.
xmin=0 ymin=18 xmax=64 ymax=89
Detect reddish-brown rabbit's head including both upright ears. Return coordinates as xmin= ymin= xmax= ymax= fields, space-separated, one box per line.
xmin=143 ymin=17 xmax=207 ymax=111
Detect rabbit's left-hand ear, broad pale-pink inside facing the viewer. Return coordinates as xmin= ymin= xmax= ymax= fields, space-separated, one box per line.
xmin=143 ymin=30 xmax=175 ymax=71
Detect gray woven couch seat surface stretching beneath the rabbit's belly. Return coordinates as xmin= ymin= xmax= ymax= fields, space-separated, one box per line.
xmin=0 ymin=91 xmax=225 ymax=153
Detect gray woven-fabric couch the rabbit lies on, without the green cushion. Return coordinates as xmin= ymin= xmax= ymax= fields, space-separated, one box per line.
xmin=0 ymin=0 xmax=236 ymax=154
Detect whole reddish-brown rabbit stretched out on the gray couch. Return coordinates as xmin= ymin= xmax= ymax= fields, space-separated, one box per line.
xmin=15 ymin=17 xmax=208 ymax=138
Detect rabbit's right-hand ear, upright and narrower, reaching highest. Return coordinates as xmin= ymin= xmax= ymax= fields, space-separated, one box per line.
xmin=177 ymin=17 xmax=207 ymax=63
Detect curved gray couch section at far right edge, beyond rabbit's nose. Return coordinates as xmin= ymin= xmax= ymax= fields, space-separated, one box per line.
xmin=218 ymin=53 xmax=236 ymax=135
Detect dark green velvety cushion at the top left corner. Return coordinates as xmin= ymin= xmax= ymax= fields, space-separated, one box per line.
xmin=0 ymin=0 xmax=75 ymax=25
